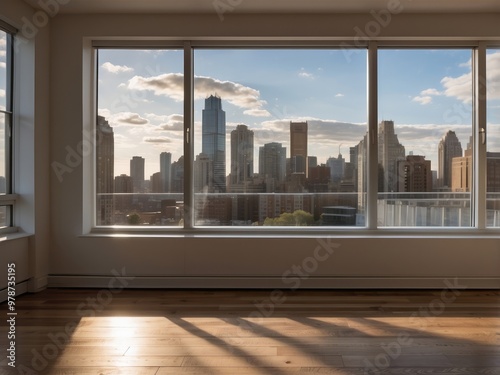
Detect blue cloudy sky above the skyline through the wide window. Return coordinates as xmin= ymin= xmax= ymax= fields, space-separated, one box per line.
xmin=96 ymin=49 xmax=500 ymax=179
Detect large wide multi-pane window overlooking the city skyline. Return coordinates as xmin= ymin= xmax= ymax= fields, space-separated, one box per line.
xmin=95 ymin=42 xmax=500 ymax=230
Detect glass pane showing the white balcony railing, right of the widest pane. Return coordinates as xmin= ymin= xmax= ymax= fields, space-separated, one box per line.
xmin=378 ymin=49 xmax=473 ymax=227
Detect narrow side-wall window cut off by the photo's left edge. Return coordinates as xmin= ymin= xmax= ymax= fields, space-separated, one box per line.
xmin=0 ymin=29 xmax=13 ymax=228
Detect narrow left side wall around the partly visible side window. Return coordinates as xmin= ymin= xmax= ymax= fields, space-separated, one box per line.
xmin=0 ymin=0 xmax=50 ymax=291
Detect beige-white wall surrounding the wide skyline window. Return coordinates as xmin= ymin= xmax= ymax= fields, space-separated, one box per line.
xmin=49 ymin=13 xmax=500 ymax=288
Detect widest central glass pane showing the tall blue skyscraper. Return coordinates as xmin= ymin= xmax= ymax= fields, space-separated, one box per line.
xmin=193 ymin=49 xmax=367 ymax=226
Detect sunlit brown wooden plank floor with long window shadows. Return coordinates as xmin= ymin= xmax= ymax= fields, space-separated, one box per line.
xmin=0 ymin=289 xmax=500 ymax=375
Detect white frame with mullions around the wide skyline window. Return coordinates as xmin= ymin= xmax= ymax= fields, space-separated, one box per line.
xmin=89 ymin=38 xmax=500 ymax=237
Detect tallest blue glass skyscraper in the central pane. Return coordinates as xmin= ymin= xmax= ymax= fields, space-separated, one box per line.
xmin=201 ymin=95 xmax=226 ymax=193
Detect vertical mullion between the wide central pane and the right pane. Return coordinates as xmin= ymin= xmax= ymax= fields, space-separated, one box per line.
xmin=366 ymin=41 xmax=378 ymax=229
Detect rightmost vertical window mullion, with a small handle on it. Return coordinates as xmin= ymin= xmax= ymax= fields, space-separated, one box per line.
xmin=472 ymin=43 xmax=487 ymax=229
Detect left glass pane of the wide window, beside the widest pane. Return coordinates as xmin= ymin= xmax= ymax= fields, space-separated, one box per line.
xmin=96 ymin=49 xmax=184 ymax=226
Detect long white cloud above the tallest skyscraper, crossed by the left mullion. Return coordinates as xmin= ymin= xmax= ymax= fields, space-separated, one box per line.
xmin=128 ymin=73 xmax=270 ymax=117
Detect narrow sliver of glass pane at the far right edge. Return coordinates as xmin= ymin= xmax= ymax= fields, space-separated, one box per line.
xmin=486 ymin=49 xmax=500 ymax=227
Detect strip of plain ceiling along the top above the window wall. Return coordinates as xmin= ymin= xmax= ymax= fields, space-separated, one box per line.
xmin=25 ymin=0 xmax=500 ymax=13
